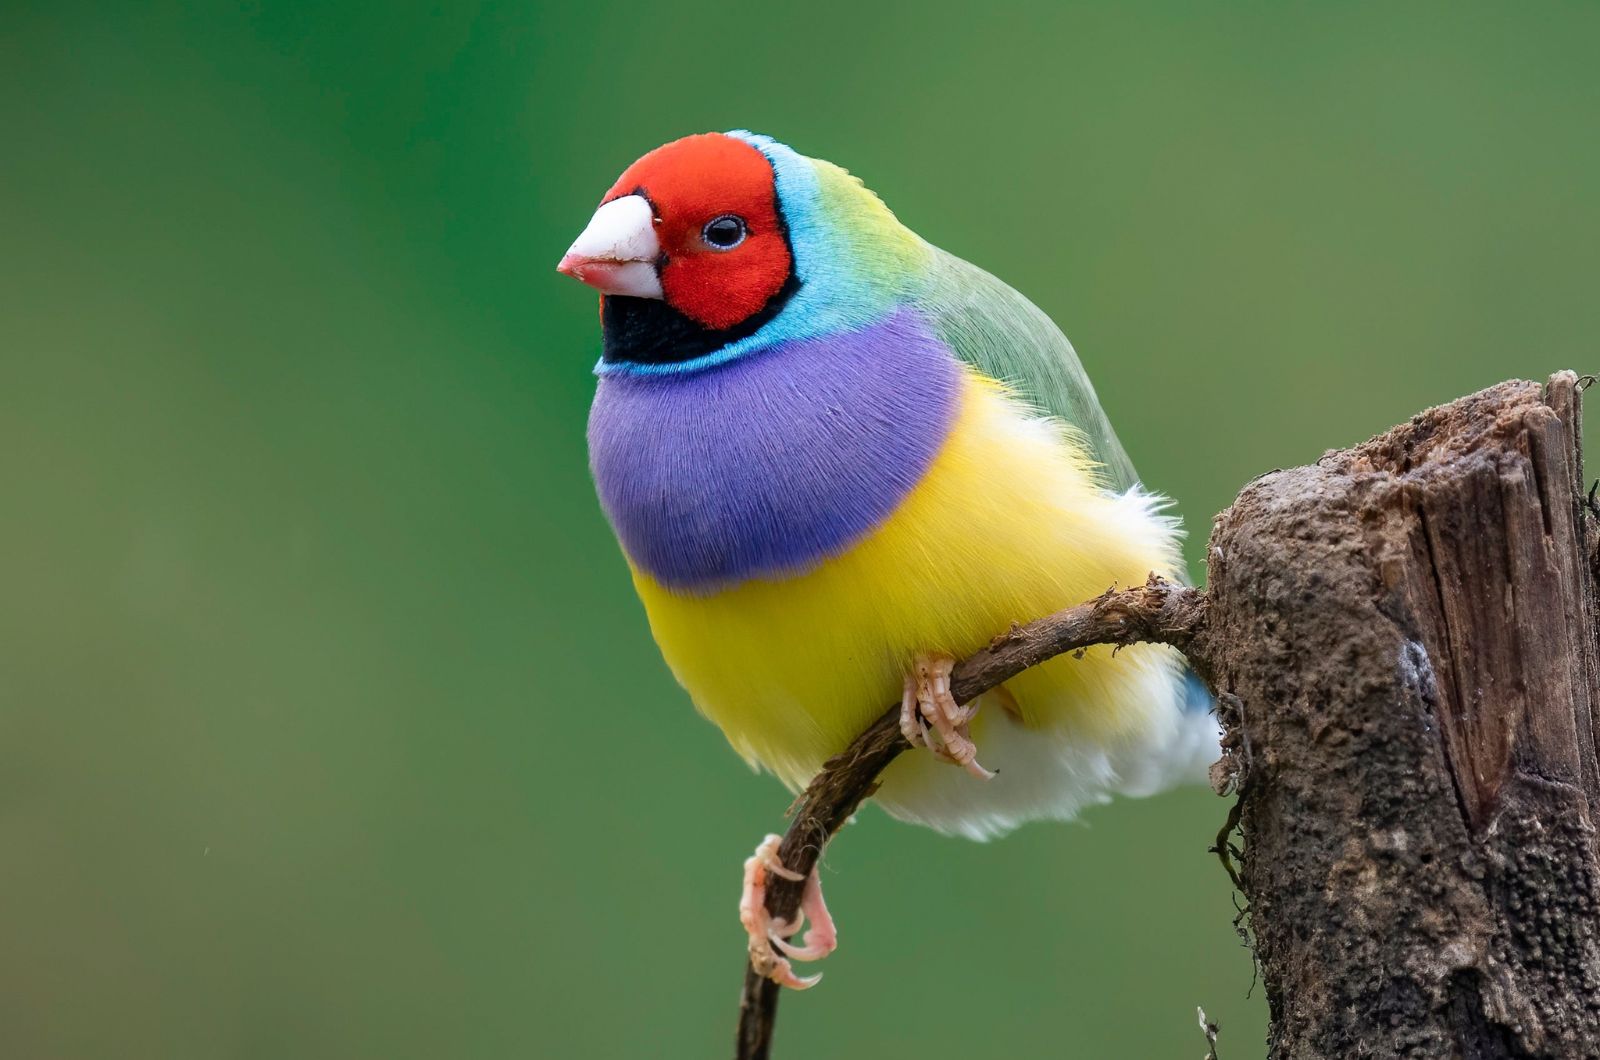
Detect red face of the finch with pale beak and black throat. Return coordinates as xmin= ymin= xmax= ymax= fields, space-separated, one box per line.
xmin=557 ymin=133 xmax=794 ymax=360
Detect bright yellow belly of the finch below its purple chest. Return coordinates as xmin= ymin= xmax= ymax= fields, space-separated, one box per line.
xmin=634 ymin=373 xmax=1178 ymax=786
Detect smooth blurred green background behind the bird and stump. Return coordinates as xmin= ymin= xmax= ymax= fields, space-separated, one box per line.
xmin=0 ymin=2 xmax=1600 ymax=1060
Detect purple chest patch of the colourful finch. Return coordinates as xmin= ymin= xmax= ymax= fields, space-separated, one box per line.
xmin=589 ymin=311 xmax=962 ymax=592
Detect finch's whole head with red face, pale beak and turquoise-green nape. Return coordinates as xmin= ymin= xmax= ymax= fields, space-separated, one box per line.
xmin=557 ymin=133 xmax=926 ymax=373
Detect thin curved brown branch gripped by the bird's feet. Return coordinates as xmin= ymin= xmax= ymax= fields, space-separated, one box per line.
xmin=734 ymin=575 xmax=1205 ymax=1060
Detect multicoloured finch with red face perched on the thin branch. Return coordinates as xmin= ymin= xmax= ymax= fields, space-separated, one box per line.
xmin=557 ymin=130 xmax=1219 ymax=988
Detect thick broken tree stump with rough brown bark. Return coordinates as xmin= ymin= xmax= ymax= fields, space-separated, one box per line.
xmin=1190 ymin=373 xmax=1600 ymax=1060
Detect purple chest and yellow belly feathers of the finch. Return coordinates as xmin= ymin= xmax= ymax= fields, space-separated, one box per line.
xmin=590 ymin=323 xmax=1178 ymax=797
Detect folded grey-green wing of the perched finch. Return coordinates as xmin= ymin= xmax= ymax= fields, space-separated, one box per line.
xmin=917 ymin=250 xmax=1139 ymax=492
